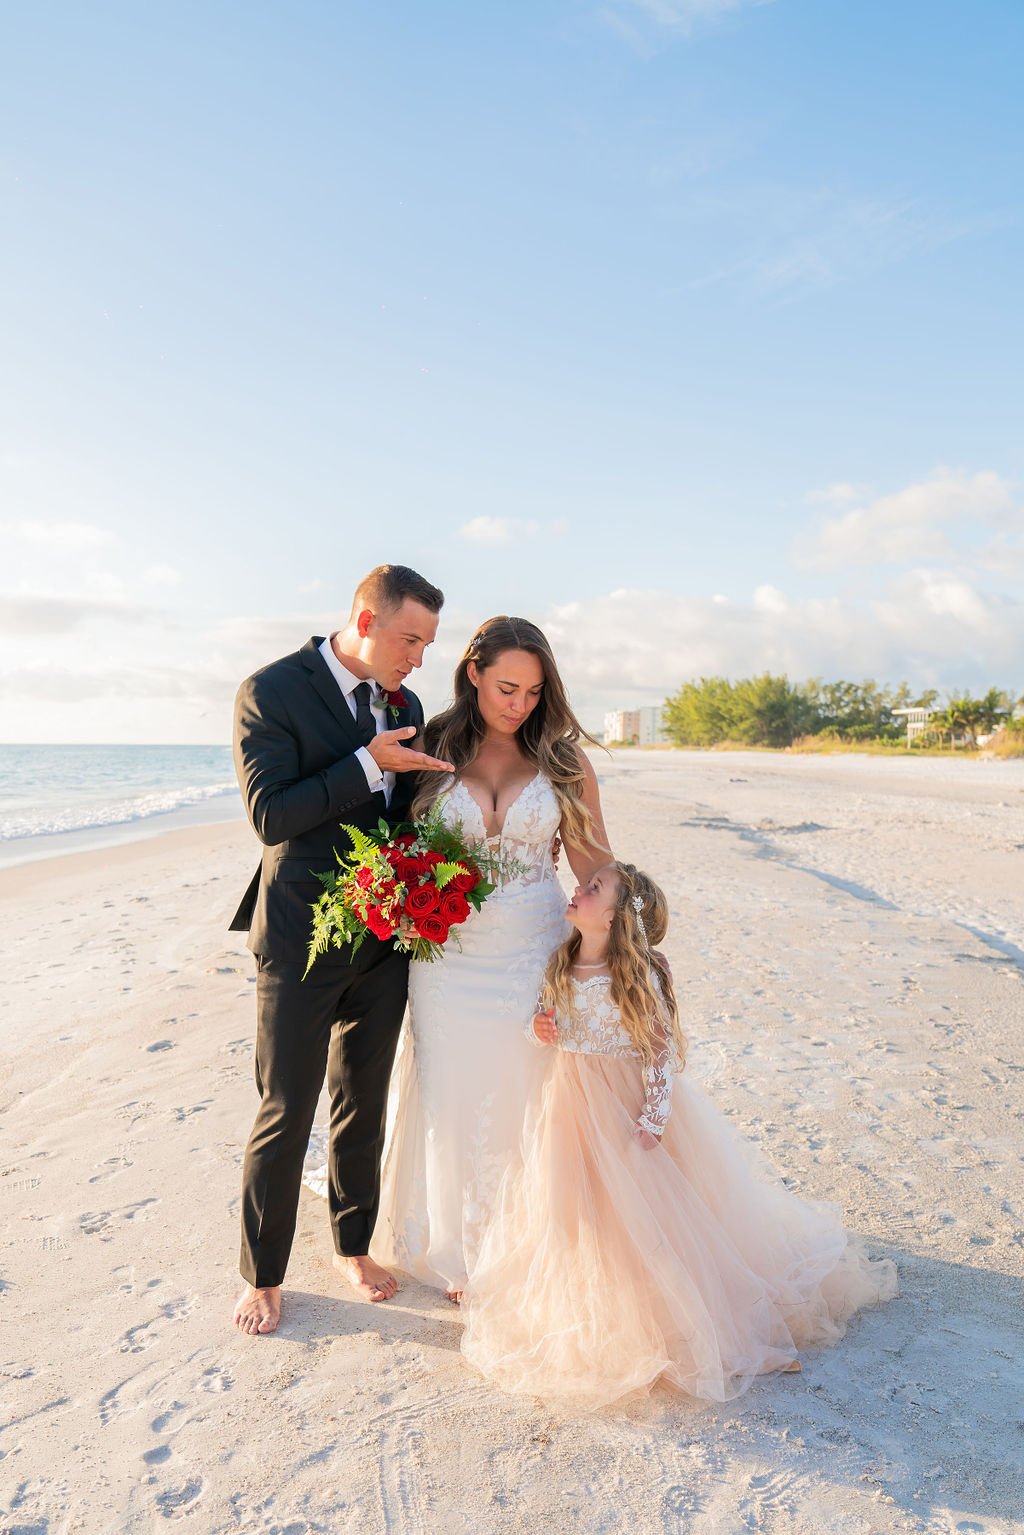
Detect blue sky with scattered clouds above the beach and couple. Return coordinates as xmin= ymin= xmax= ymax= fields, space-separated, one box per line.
xmin=0 ymin=0 xmax=1024 ymax=741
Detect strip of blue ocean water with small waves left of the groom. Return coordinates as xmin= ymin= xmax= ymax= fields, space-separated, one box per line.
xmin=0 ymin=744 xmax=241 ymax=864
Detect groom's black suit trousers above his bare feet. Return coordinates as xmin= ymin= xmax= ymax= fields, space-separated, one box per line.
xmin=241 ymin=938 xmax=408 ymax=1286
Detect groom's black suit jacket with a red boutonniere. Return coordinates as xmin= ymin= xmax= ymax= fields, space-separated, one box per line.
xmin=230 ymin=635 xmax=424 ymax=964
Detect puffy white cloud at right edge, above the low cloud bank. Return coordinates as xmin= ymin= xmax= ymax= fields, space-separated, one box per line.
xmin=794 ymin=467 xmax=1024 ymax=568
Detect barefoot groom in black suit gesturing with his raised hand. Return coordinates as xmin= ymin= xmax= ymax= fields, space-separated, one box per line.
xmin=232 ymin=565 xmax=451 ymax=1335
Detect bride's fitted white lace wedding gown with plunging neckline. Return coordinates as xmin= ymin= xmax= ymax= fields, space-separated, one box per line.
xmin=370 ymin=772 xmax=570 ymax=1289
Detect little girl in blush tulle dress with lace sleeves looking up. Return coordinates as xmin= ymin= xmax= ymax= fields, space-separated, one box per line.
xmin=462 ymin=863 xmax=895 ymax=1408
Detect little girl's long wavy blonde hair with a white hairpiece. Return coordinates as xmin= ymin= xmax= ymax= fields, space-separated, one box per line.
xmin=540 ymin=863 xmax=686 ymax=1065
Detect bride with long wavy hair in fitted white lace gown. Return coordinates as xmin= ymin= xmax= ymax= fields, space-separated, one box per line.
xmin=370 ymin=617 xmax=611 ymax=1302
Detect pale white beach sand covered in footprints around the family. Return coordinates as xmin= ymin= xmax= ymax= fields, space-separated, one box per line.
xmin=0 ymin=752 xmax=1024 ymax=1535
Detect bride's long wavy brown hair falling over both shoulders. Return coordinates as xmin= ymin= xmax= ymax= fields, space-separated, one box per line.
xmin=411 ymin=614 xmax=599 ymax=846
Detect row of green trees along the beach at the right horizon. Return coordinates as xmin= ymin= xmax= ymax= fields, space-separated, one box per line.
xmin=665 ymin=672 xmax=1019 ymax=746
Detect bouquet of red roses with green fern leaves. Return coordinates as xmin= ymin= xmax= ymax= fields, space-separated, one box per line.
xmin=306 ymin=815 xmax=509 ymax=975
